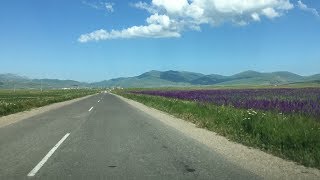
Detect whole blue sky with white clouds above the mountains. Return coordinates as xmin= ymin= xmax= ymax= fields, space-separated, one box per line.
xmin=0 ymin=0 xmax=320 ymax=82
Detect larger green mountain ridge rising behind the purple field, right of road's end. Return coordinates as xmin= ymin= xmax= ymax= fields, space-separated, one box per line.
xmin=92 ymin=70 xmax=320 ymax=87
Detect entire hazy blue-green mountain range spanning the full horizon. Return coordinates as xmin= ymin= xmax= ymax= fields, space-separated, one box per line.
xmin=0 ymin=70 xmax=320 ymax=89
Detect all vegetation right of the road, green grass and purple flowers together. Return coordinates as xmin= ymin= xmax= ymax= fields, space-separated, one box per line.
xmin=115 ymin=88 xmax=320 ymax=169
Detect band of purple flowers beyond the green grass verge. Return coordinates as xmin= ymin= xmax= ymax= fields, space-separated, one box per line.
xmin=131 ymin=88 xmax=320 ymax=118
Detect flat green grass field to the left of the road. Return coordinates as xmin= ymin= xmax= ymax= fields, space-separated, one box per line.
xmin=0 ymin=89 xmax=98 ymax=117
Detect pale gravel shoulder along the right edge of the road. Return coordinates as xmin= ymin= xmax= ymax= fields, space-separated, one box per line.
xmin=115 ymin=95 xmax=320 ymax=179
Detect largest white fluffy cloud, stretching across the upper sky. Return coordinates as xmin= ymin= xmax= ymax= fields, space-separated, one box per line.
xmin=79 ymin=0 xmax=293 ymax=42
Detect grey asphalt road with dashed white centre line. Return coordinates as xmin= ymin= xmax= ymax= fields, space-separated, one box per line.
xmin=0 ymin=93 xmax=260 ymax=180
